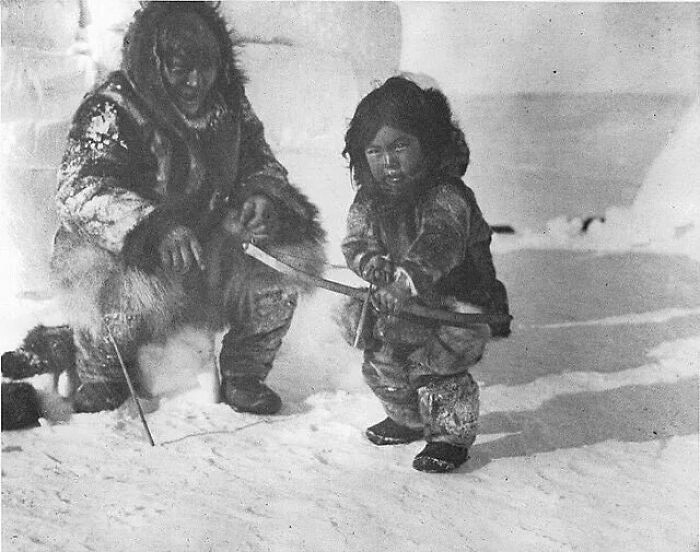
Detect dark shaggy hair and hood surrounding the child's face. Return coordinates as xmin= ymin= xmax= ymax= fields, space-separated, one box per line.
xmin=343 ymin=77 xmax=469 ymax=187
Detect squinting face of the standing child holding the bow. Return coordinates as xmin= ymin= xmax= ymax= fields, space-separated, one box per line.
xmin=365 ymin=126 xmax=426 ymax=198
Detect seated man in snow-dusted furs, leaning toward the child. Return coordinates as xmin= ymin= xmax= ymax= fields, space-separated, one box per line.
xmin=46 ymin=2 xmax=324 ymax=414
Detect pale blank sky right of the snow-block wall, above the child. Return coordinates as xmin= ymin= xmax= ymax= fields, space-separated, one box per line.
xmin=399 ymin=2 xmax=700 ymax=93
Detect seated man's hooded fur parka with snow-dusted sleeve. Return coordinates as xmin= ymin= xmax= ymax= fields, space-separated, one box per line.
xmin=52 ymin=2 xmax=325 ymax=334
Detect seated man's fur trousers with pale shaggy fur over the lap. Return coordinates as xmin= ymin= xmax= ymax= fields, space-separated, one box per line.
xmin=48 ymin=229 xmax=308 ymax=410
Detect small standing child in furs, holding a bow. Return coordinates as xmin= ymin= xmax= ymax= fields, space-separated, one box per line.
xmin=342 ymin=77 xmax=509 ymax=473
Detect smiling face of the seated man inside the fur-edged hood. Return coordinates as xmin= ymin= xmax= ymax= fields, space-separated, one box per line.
xmin=163 ymin=52 xmax=219 ymax=117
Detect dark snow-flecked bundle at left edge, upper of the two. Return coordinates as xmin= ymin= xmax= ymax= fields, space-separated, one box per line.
xmin=2 ymin=325 xmax=75 ymax=379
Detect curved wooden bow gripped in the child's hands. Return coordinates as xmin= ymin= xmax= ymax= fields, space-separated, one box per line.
xmin=243 ymin=242 xmax=513 ymax=328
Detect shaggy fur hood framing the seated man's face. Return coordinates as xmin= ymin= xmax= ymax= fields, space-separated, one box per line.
xmin=121 ymin=1 xmax=246 ymax=135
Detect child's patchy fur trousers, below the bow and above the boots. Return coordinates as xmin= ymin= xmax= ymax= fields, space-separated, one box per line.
xmin=348 ymin=298 xmax=491 ymax=447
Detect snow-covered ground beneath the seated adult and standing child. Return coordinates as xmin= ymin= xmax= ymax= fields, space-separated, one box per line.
xmin=0 ymin=92 xmax=700 ymax=552
